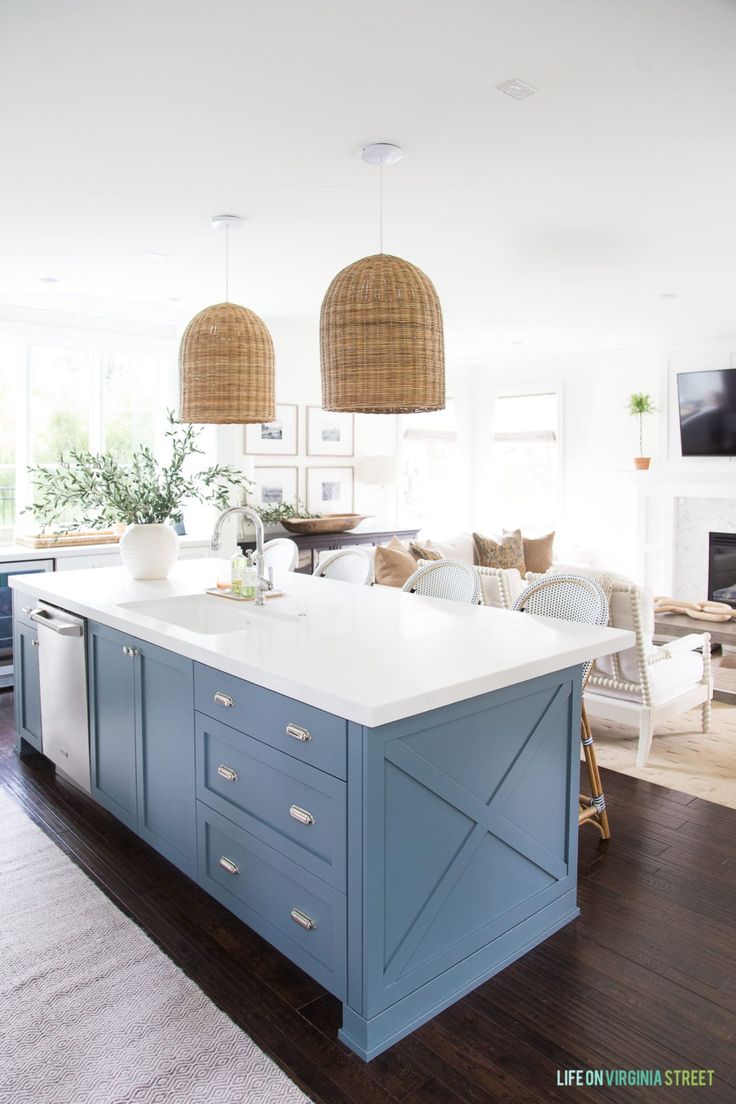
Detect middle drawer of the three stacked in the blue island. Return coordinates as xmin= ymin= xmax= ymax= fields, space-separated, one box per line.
xmin=195 ymin=713 xmax=346 ymax=892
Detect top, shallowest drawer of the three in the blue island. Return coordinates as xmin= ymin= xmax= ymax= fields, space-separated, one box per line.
xmin=194 ymin=664 xmax=348 ymax=778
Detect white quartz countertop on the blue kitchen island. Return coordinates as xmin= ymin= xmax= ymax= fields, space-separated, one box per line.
xmin=10 ymin=559 xmax=634 ymax=728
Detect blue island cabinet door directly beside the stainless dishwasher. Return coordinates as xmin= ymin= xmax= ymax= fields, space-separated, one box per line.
xmin=88 ymin=623 xmax=138 ymax=831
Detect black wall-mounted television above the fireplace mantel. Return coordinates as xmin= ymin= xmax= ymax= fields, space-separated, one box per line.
xmin=678 ymin=368 xmax=736 ymax=456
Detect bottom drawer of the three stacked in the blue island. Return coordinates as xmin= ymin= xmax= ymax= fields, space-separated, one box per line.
xmin=196 ymin=802 xmax=346 ymax=999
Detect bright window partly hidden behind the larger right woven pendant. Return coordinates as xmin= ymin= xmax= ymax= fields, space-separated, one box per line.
xmin=399 ymin=399 xmax=467 ymax=535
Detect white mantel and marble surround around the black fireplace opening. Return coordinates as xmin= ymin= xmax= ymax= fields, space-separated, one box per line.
xmin=637 ymin=464 xmax=736 ymax=602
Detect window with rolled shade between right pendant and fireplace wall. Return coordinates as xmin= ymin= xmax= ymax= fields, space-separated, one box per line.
xmin=491 ymin=389 xmax=561 ymax=529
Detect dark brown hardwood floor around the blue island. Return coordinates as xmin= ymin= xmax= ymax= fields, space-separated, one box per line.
xmin=0 ymin=693 xmax=736 ymax=1104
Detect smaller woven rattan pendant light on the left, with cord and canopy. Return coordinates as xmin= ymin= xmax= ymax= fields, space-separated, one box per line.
xmin=179 ymin=214 xmax=276 ymax=425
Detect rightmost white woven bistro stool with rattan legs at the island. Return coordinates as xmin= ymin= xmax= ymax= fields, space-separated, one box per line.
xmin=513 ymin=575 xmax=610 ymax=839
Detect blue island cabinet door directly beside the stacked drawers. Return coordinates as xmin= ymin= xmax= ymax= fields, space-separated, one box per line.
xmin=135 ymin=640 xmax=196 ymax=878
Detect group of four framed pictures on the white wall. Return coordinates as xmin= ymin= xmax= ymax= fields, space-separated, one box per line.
xmin=243 ymin=403 xmax=355 ymax=513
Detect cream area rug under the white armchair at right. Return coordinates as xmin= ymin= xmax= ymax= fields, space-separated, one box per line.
xmin=590 ymin=702 xmax=736 ymax=809
